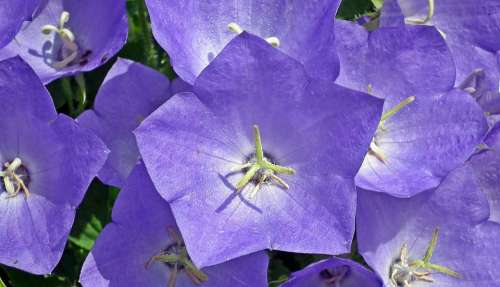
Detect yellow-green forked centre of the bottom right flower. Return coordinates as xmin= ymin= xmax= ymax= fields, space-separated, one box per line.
xmin=390 ymin=228 xmax=460 ymax=287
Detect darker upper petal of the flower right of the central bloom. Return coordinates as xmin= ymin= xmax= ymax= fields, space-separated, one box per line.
xmin=336 ymin=20 xmax=455 ymax=106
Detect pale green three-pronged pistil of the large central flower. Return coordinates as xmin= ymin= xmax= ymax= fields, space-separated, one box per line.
xmin=236 ymin=125 xmax=295 ymax=196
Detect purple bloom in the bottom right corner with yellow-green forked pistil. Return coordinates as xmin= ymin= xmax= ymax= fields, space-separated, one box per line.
xmin=356 ymin=163 xmax=500 ymax=287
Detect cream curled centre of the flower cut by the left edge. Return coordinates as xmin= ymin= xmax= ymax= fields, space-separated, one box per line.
xmin=0 ymin=157 xmax=30 ymax=198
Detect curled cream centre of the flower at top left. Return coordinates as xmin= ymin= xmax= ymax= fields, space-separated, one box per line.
xmin=42 ymin=11 xmax=79 ymax=69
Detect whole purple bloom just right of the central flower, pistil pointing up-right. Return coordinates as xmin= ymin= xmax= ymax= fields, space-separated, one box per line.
xmin=336 ymin=21 xmax=488 ymax=197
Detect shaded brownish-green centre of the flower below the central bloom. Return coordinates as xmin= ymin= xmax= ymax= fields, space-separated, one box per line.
xmin=146 ymin=228 xmax=208 ymax=287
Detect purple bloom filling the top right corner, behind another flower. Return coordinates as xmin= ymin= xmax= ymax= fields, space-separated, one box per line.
xmin=381 ymin=0 xmax=500 ymax=119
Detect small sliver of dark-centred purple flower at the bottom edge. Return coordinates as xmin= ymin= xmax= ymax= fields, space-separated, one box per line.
xmin=281 ymin=257 xmax=382 ymax=287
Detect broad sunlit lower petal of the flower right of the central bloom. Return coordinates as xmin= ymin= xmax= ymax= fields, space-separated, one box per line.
xmin=356 ymin=90 xmax=488 ymax=197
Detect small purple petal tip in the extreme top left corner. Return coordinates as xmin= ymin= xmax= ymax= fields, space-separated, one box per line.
xmin=0 ymin=0 xmax=38 ymax=49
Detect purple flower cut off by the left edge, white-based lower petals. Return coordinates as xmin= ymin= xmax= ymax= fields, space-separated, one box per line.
xmin=0 ymin=57 xmax=108 ymax=274
